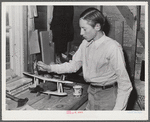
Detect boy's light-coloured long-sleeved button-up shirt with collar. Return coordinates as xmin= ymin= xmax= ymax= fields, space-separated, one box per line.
xmin=51 ymin=34 xmax=132 ymax=110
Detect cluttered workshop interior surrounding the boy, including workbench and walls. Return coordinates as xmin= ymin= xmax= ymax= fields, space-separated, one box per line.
xmin=5 ymin=5 xmax=145 ymax=111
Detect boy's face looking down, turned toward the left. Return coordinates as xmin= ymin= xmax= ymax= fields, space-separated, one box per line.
xmin=79 ymin=18 xmax=97 ymax=42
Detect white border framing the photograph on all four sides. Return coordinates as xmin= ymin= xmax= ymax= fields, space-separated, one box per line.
xmin=1 ymin=1 xmax=148 ymax=121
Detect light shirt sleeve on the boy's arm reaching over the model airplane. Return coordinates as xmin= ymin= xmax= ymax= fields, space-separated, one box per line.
xmin=50 ymin=43 xmax=82 ymax=74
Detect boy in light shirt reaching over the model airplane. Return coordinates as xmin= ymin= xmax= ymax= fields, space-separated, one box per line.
xmin=38 ymin=8 xmax=132 ymax=110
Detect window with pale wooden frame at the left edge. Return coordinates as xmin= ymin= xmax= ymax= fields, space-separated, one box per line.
xmin=4 ymin=5 xmax=27 ymax=76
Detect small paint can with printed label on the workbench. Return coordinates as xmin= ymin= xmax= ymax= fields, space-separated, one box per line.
xmin=73 ymin=85 xmax=82 ymax=97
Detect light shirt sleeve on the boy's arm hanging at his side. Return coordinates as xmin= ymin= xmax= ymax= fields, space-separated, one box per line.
xmin=110 ymin=45 xmax=132 ymax=110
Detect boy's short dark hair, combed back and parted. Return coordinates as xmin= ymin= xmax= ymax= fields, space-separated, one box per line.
xmin=80 ymin=8 xmax=105 ymax=30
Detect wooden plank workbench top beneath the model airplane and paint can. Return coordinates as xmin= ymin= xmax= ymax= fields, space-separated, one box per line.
xmin=6 ymin=83 xmax=88 ymax=110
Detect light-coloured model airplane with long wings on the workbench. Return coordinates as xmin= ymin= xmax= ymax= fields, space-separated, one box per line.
xmin=23 ymin=72 xmax=73 ymax=96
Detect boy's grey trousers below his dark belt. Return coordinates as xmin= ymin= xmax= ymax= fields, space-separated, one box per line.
xmin=86 ymin=86 xmax=117 ymax=110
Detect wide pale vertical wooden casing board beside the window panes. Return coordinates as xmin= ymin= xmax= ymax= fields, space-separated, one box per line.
xmin=9 ymin=6 xmax=24 ymax=76
